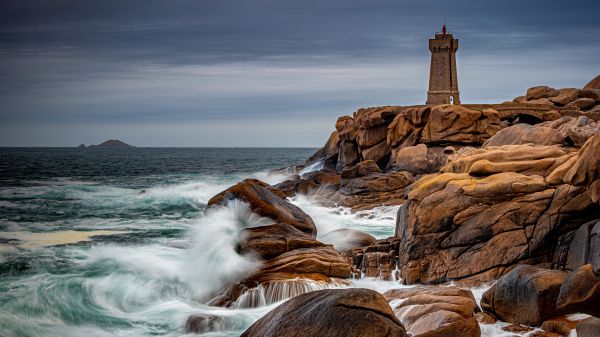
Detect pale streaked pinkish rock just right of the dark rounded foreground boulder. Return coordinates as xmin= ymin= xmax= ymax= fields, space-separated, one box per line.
xmin=383 ymin=286 xmax=481 ymax=337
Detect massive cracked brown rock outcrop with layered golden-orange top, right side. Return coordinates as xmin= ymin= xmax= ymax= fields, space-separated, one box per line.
xmin=396 ymin=140 xmax=599 ymax=284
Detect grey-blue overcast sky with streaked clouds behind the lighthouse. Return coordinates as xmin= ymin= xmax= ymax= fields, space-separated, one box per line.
xmin=0 ymin=0 xmax=600 ymax=146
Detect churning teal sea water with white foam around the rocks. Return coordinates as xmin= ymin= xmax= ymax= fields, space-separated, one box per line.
xmin=0 ymin=148 xmax=400 ymax=337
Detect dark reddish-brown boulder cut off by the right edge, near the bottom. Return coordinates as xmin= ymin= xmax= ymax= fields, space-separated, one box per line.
xmin=556 ymin=264 xmax=600 ymax=316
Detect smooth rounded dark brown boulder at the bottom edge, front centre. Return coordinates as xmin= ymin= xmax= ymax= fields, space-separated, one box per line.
xmin=242 ymin=289 xmax=406 ymax=337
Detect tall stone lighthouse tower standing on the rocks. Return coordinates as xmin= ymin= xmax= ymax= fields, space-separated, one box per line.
xmin=427 ymin=25 xmax=460 ymax=104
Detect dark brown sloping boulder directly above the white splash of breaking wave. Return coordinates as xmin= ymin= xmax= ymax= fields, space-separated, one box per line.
xmin=208 ymin=179 xmax=317 ymax=237
